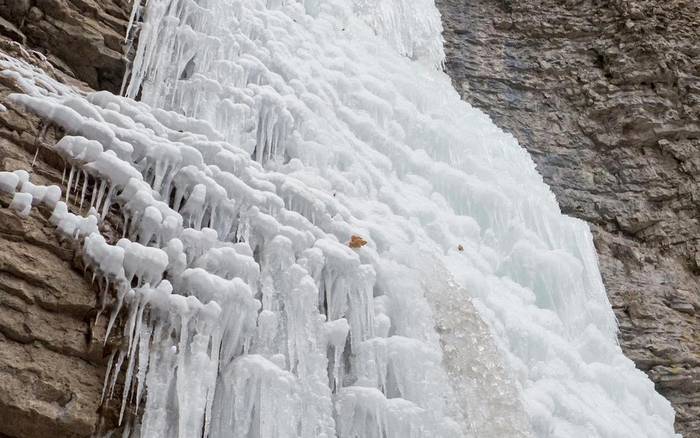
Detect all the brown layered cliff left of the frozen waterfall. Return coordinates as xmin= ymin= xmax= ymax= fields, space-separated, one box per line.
xmin=0 ymin=0 xmax=128 ymax=437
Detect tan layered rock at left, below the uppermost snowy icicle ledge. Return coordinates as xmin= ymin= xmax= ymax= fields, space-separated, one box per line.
xmin=0 ymin=39 xmax=116 ymax=437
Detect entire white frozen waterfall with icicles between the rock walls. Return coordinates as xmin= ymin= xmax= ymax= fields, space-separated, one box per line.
xmin=0 ymin=0 xmax=675 ymax=438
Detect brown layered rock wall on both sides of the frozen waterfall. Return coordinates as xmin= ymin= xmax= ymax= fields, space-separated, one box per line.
xmin=0 ymin=0 xmax=700 ymax=438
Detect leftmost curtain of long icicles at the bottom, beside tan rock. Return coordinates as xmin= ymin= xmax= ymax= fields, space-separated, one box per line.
xmin=114 ymin=280 xmax=221 ymax=437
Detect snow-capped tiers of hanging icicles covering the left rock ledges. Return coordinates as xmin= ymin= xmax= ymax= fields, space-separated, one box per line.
xmin=0 ymin=55 xmax=470 ymax=438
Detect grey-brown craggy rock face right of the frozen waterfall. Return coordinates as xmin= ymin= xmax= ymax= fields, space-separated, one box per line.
xmin=437 ymin=0 xmax=700 ymax=438
